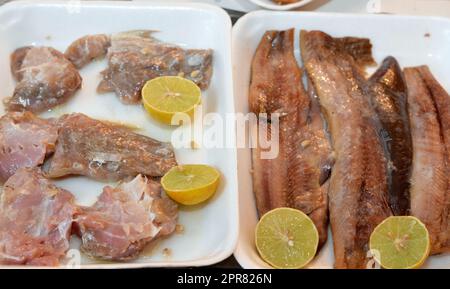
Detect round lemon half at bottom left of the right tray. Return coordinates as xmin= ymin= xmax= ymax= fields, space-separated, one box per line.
xmin=255 ymin=208 xmax=319 ymax=269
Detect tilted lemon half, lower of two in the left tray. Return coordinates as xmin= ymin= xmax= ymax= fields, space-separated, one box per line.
xmin=161 ymin=165 xmax=220 ymax=205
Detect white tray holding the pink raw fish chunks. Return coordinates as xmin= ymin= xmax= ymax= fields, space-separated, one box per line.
xmin=0 ymin=1 xmax=238 ymax=268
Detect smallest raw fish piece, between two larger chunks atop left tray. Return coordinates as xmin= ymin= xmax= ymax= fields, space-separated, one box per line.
xmin=64 ymin=34 xmax=111 ymax=69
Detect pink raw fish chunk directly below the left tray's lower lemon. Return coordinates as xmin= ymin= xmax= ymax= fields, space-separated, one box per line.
xmin=75 ymin=175 xmax=178 ymax=261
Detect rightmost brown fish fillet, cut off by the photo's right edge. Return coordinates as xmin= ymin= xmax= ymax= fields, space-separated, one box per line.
xmin=404 ymin=66 xmax=450 ymax=254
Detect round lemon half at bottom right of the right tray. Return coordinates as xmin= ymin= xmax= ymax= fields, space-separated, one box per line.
xmin=369 ymin=216 xmax=430 ymax=269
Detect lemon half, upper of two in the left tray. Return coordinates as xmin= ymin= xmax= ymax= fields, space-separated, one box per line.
xmin=142 ymin=76 xmax=201 ymax=124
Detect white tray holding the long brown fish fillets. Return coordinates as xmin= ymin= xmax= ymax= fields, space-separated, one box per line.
xmin=232 ymin=11 xmax=450 ymax=268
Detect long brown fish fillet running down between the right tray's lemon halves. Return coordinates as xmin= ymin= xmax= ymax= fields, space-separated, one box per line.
xmin=300 ymin=31 xmax=392 ymax=268
